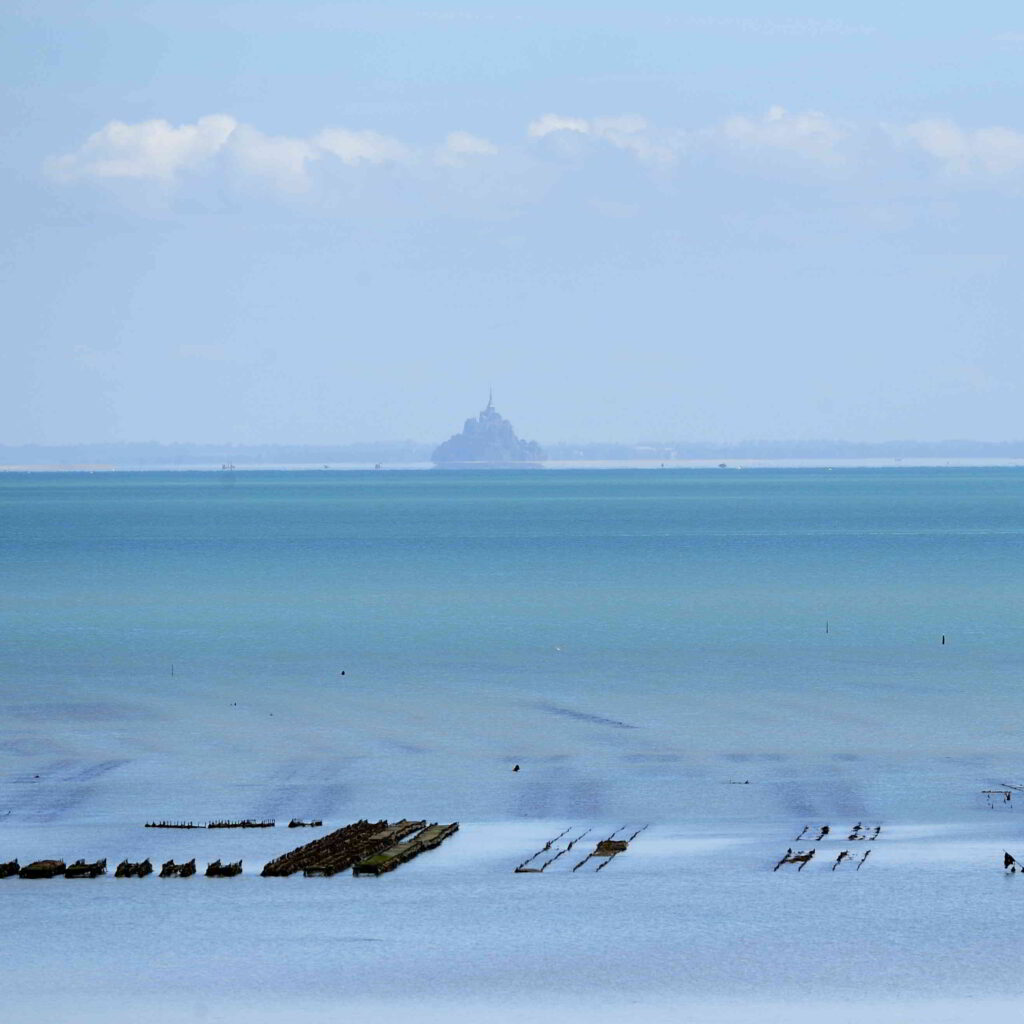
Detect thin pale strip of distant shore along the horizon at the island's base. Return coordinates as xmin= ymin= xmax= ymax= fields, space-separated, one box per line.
xmin=0 ymin=457 xmax=1024 ymax=473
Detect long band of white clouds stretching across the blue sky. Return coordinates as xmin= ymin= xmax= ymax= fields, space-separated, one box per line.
xmin=44 ymin=105 xmax=1024 ymax=202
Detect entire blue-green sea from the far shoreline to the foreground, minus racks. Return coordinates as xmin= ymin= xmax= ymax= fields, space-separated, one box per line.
xmin=0 ymin=468 xmax=1024 ymax=1020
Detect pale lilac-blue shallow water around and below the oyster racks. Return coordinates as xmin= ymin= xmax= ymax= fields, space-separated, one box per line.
xmin=6 ymin=814 xmax=1024 ymax=1021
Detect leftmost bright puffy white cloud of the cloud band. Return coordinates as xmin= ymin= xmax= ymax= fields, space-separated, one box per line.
xmin=46 ymin=114 xmax=238 ymax=181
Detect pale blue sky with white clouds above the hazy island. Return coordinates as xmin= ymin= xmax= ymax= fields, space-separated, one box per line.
xmin=6 ymin=0 xmax=1024 ymax=444
